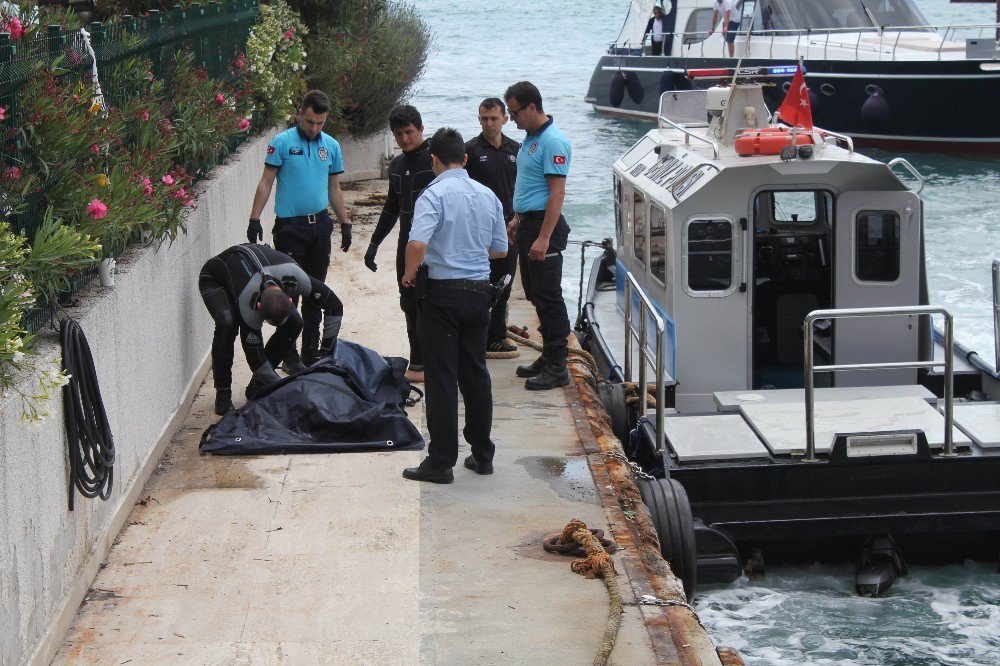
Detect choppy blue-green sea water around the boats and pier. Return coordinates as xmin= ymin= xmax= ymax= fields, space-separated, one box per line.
xmin=412 ymin=0 xmax=1000 ymax=665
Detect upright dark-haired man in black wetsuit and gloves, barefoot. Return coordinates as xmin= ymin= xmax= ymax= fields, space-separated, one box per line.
xmin=365 ymin=104 xmax=434 ymax=382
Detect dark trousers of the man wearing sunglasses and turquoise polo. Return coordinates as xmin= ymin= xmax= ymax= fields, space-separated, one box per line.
xmin=517 ymin=213 xmax=570 ymax=367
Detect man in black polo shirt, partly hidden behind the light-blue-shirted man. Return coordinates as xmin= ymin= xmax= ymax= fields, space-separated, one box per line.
xmin=465 ymin=97 xmax=521 ymax=358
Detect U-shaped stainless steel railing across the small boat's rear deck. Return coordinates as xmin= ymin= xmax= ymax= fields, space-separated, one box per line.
xmin=802 ymin=306 xmax=956 ymax=462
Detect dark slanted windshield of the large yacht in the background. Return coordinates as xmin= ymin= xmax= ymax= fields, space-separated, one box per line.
xmin=742 ymin=0 xmax=927 ymax=30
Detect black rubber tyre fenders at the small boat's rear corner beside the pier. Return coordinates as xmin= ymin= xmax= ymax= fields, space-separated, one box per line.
xmin=637 ymin=479 xmax=698 ymax=602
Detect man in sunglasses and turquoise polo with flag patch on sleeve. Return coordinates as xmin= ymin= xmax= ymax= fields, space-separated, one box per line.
xmin=504 ymin=81 xmax=572 ymax=391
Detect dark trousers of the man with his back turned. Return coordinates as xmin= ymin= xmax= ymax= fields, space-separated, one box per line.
xmin=418 ymin=286 xmax=494 ymax=470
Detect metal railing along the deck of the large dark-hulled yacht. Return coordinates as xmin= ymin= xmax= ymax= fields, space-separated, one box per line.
xmin=608 ymin=23 xmax=1000 ymax=60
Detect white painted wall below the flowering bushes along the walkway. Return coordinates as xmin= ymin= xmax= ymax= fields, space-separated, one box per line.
xmin=0 ymin=135 xmax=284 ymax=666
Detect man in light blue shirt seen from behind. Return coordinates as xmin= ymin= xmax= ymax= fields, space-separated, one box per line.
xmin=403 ymin=127 xmax=507 ymax=483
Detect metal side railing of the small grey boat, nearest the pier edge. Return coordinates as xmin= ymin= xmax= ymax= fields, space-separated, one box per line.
xmin=625 ymin=272 xmax=665 ymax=453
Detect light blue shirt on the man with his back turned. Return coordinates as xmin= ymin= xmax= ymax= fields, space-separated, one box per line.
xmin=410 ymin=169 xmax=507 ymax=280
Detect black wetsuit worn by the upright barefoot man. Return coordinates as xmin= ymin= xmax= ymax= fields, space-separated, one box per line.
xmin=371 ymin=141 xmax=434 ymax=371
